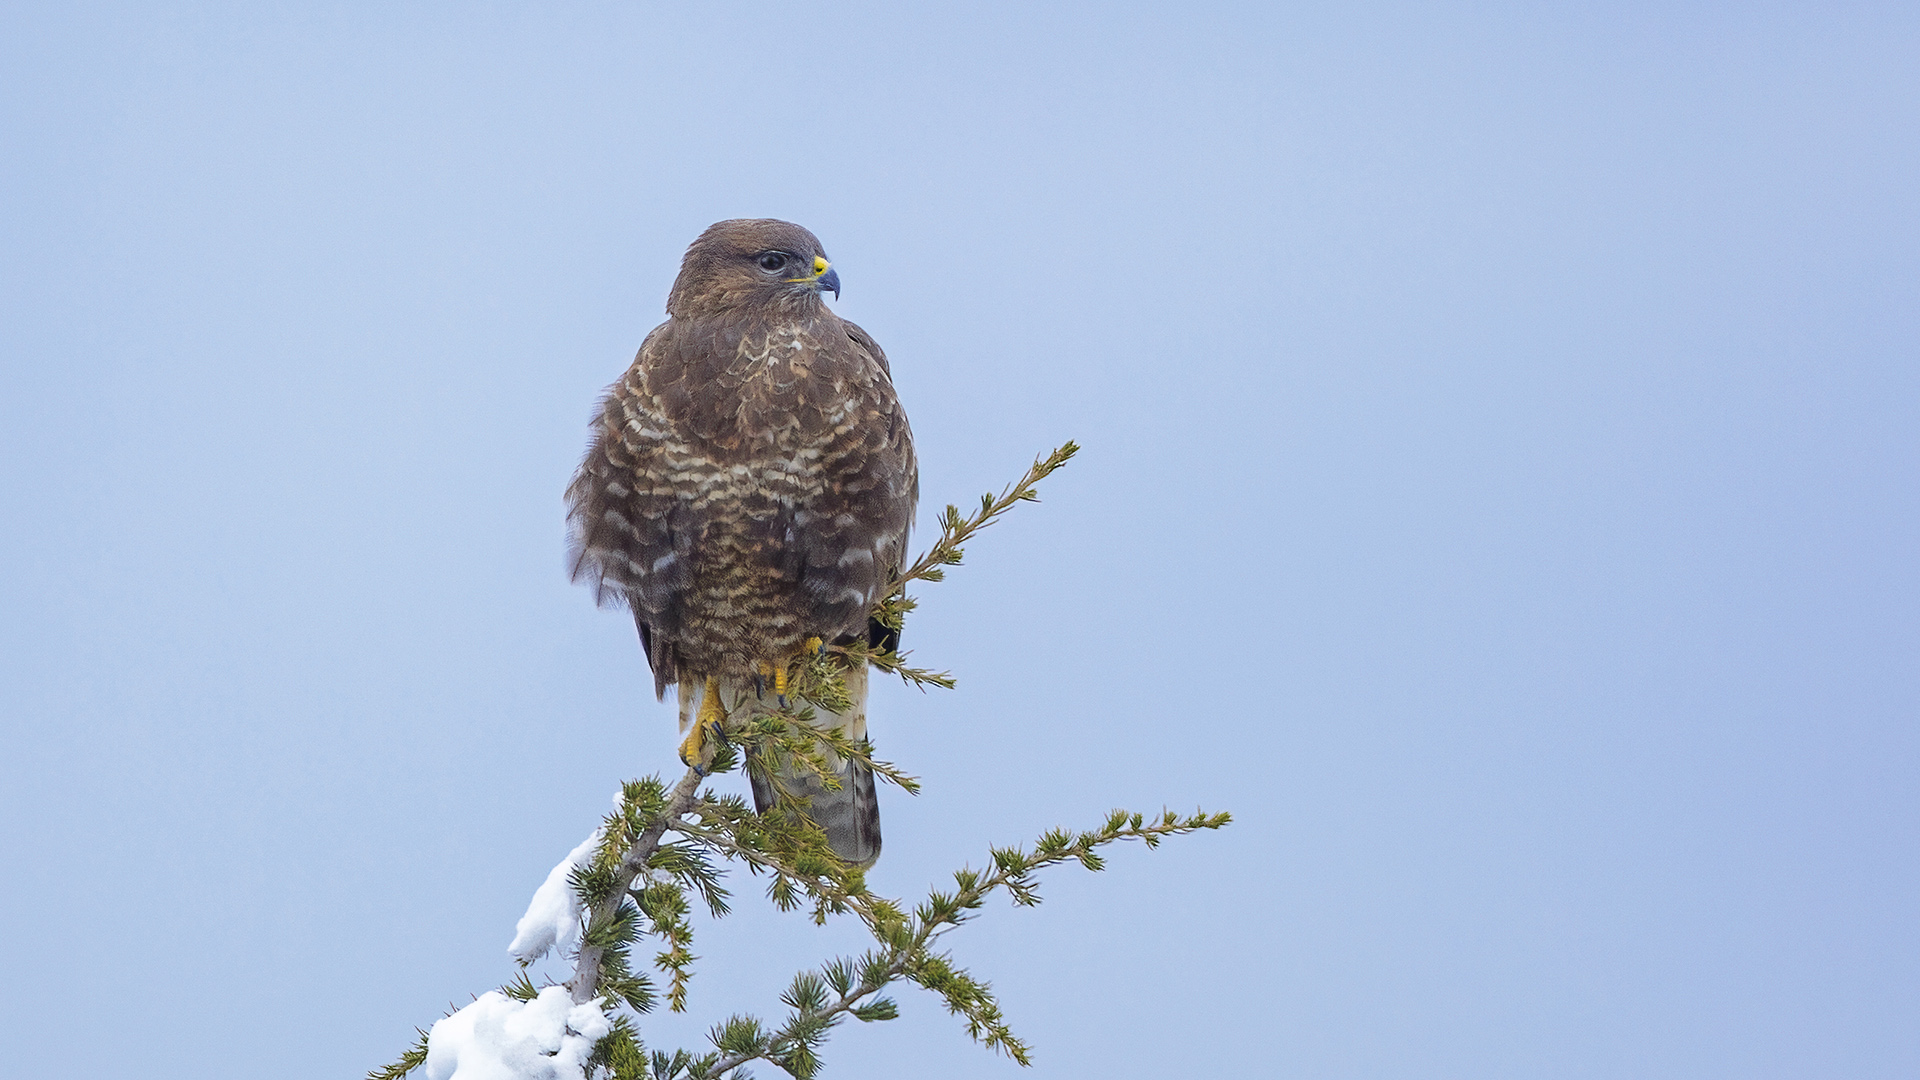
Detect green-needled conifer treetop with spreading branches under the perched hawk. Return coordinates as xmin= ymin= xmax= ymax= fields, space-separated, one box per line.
xmin=369 ymin=442 xmax=1231 ymax=1080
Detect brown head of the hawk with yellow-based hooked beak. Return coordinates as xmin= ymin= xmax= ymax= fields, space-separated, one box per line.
xmin=666 ymin=217 xmax=839 ymax=317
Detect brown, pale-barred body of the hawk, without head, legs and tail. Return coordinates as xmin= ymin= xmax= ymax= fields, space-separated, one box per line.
xmin=566 ymin=309 xmax=920 ymax=696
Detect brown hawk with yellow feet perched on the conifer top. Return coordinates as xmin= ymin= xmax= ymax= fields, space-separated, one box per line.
xmin=566 ymin=219 xmax=920 ymax=865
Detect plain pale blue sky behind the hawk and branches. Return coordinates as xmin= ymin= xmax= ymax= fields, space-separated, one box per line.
xmin=0 ymin=2 xmax=1920 ymax=1080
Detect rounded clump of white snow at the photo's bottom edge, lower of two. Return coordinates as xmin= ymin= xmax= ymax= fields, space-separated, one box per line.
xmin=426 ymin=986 xmax=612 ymax=1080
